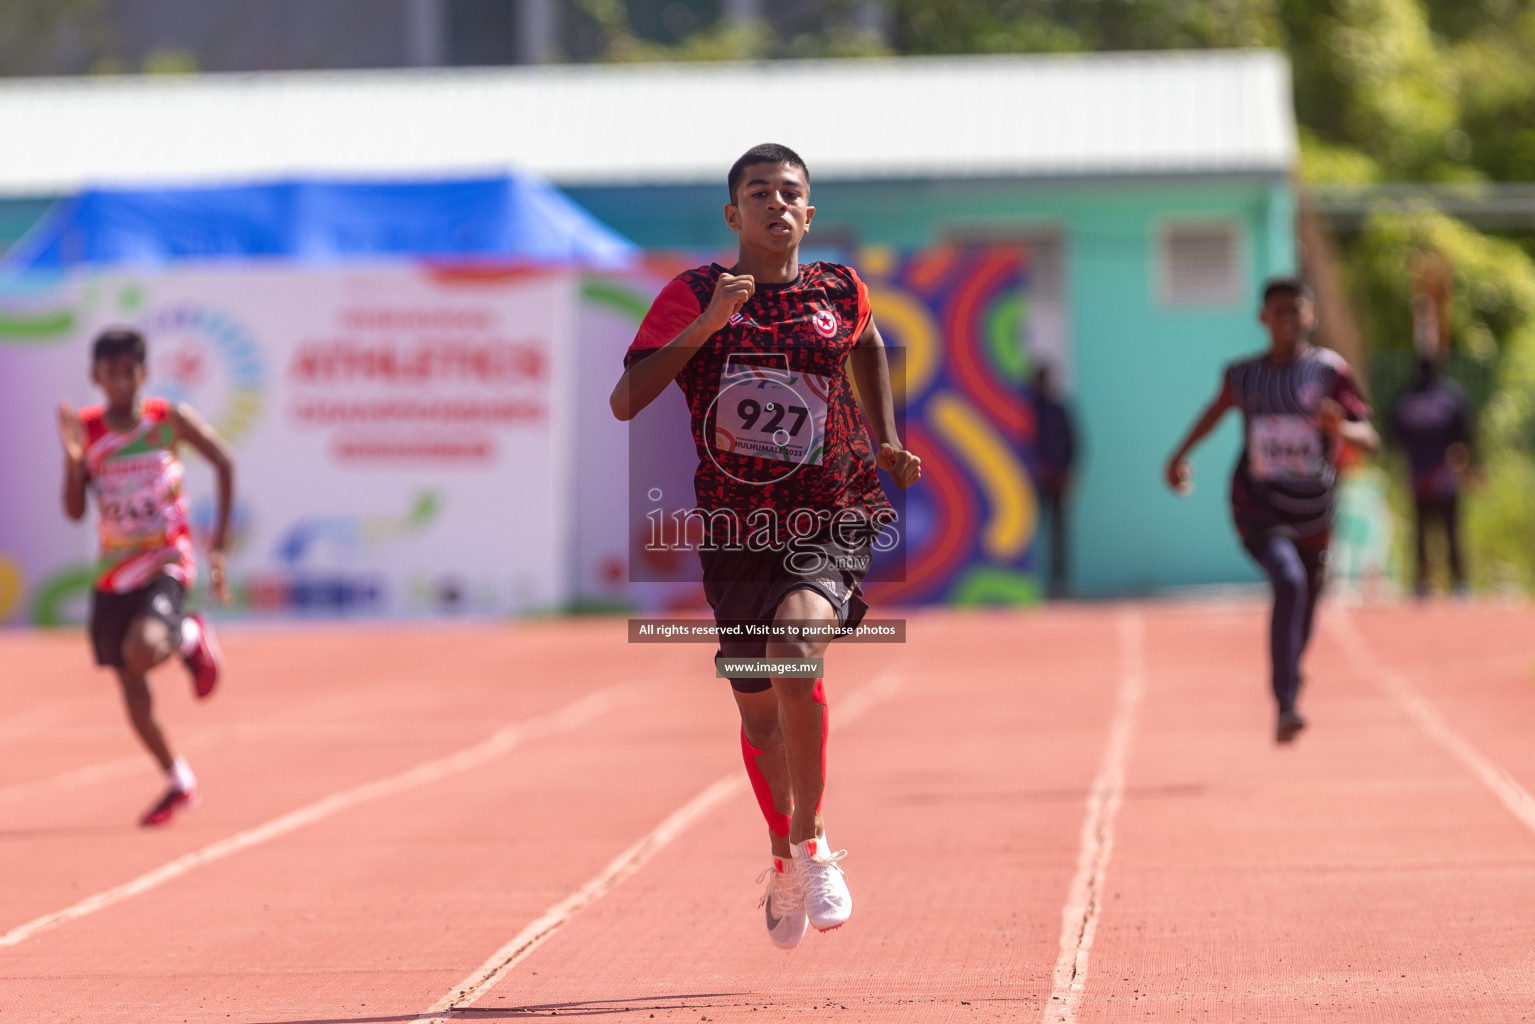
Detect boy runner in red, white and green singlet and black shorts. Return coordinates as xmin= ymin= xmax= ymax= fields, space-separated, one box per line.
xmin=58 ymin=329 xmax=233 ymax=826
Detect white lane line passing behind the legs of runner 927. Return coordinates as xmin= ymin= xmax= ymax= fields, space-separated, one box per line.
xmin=413 ymin=671 xmax=901 ymax=1024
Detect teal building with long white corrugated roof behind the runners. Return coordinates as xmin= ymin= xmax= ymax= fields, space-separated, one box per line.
xmin=0 ymin=52 xmax=1296 ymax=607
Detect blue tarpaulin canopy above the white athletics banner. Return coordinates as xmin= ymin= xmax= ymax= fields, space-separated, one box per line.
xmin=0 ymin=173 xmax=637 ymax=270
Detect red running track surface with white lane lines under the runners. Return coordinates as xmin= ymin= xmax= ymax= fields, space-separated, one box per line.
xmin=0 ymin=603 xmax=1535 ymax=1024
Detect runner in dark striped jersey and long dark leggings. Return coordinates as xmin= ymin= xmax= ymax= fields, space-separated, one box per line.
xmin=1167 ymin=278 xmax=1380 ymax=743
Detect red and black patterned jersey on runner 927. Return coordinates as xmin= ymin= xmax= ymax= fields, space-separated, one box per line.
xmin=625 ymin=263 xmax=889 ymax=514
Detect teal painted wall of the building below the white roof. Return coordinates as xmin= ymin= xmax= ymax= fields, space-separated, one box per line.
xmin=566 ymin=177 xmax=1294 ymax=597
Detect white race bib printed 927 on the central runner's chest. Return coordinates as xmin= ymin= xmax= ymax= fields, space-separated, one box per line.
xmin=714 ymin=356 xmax=832 ymax=465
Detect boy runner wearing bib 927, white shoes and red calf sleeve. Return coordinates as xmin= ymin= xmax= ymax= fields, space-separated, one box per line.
xmin=611 ymin=144 xmax=921 ymax=949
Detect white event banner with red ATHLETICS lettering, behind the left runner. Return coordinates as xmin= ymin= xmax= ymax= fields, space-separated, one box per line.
xmin=0 ymin=264 xmax=579 ymax=623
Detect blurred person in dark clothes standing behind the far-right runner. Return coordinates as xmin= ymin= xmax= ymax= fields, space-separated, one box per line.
xmin=1391 ymin=358 xmax=1472 ymax=597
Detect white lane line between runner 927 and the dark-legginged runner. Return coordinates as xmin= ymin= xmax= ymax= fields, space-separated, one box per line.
xmin=1042 ymin=608 xmax=1145 ymax=1024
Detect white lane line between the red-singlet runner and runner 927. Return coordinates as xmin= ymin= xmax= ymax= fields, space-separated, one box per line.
xmin=0 ymin=683 xmax=639 ymax=947
